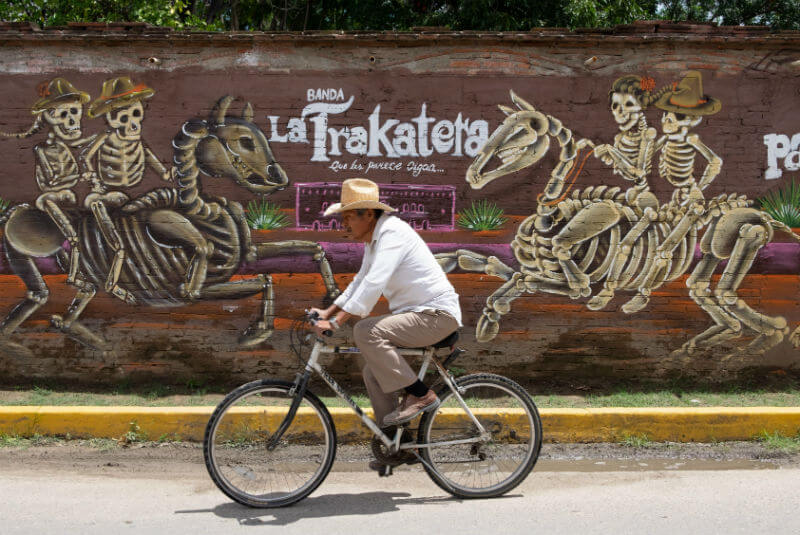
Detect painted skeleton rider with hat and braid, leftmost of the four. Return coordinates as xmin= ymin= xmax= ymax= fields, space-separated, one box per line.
xmin=0 ymin=78 xmax=95 ymax=286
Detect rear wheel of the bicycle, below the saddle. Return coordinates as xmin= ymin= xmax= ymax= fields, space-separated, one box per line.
xmin=417 ymin=374 xmax=542 ymax=498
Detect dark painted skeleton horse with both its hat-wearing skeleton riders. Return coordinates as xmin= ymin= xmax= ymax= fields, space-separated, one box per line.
xmin=0 ymin=77 xmax=339 ymax=351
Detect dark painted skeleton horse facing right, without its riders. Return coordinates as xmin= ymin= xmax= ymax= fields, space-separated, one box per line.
xmin=0 ymin=96 xmax=339 ymax=349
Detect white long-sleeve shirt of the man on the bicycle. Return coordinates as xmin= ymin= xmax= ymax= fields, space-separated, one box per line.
xmin=334 ymin=214 xmax=461 ymax=325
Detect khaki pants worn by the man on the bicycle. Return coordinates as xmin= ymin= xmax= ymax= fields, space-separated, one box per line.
xmin=353 ymin=310 xmax=458 ymax=425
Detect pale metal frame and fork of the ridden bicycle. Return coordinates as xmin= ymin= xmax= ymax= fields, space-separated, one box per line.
xmin=282 ymin=338 xmax=489 ymax=453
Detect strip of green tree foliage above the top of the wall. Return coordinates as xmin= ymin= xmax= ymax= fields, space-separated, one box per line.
xmin=0 ymin=0 xmax=800 ymax=31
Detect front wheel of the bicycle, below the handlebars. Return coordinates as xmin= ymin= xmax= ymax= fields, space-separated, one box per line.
xmin=203 ymin=379 xmax=336 ymax=507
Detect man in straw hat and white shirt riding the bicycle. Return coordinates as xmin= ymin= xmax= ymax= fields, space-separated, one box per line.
xmin=312 ymin=178 xmax=461 ymax=470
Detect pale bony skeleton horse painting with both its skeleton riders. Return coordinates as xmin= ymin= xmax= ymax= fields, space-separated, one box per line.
xmin=437 ymin=71 xmax=800 ymax=360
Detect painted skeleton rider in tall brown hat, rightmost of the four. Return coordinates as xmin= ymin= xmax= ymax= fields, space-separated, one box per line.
xmin=622 ymin=71 xmax=722 ymax=314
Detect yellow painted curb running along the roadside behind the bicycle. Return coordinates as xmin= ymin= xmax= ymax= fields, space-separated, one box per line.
xmin=0 ymin=406 xmax=800 ymax=442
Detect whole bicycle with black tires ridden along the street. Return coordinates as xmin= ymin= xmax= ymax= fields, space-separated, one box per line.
xmin=203 ymin=312 xmax=542 ymax=508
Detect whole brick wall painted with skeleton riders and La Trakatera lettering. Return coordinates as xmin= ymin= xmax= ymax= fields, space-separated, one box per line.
xmin=0 ymin=24 xmax=800 ymax=384
